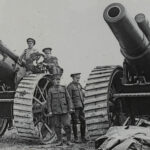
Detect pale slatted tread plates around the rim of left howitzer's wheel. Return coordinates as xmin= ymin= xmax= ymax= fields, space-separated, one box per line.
xmin=14 ymin=74 xmax=45 ymax=140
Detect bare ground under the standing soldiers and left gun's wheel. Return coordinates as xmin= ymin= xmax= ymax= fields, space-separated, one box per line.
xmin=0 ymin=129 xmax=94 ymax=150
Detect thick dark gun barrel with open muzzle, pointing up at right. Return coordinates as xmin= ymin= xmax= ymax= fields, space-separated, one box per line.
xmin=103 ymin=3 xmax=150 ymax=76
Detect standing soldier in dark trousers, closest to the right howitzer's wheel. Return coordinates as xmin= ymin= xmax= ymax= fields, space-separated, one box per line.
xmin=67 ymin=73 xmax=87 ymax=143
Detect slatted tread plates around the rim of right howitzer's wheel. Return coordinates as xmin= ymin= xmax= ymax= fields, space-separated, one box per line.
xmin=84 ymin=66 xmax=116 ymax=140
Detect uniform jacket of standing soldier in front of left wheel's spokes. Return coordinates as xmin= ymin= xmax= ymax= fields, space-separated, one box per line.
xmin=47 ymin=86 xmax=73 ymax=114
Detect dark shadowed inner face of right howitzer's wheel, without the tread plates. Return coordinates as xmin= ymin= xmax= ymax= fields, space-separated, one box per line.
xmin=107 ymin=67 xmax=126 ymax=126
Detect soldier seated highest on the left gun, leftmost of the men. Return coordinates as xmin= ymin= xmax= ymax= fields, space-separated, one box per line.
xmin=20 ymin=38 xmax=42 ymax=73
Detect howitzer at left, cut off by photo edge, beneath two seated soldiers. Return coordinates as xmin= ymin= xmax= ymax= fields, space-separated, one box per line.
xmin=0 ymin=42 xmax=55 ymax=143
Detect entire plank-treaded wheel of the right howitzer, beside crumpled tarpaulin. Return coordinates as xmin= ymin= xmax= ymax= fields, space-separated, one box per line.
xmin=84 ymin=66 xmax=122 ymax=140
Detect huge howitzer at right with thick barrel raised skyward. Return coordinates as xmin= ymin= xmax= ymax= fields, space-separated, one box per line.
xmin=85 ymin=3 xmax=150 ymax=143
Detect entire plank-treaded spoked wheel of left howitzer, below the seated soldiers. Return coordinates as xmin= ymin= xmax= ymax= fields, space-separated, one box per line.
xmin=14 ymin=74 xmax=55 ymax=144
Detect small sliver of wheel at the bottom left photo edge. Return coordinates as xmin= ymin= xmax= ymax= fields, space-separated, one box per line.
xmin=0 ymin=118 xmax=8 ymax=137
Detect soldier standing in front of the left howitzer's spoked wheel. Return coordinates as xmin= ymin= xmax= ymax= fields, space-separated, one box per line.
xmin=47 ymin=75 xmax=73 ymax=146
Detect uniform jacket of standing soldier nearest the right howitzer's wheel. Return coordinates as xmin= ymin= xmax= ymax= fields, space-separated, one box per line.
xmin=67 ymin=82 xmax=84 ymax=108
